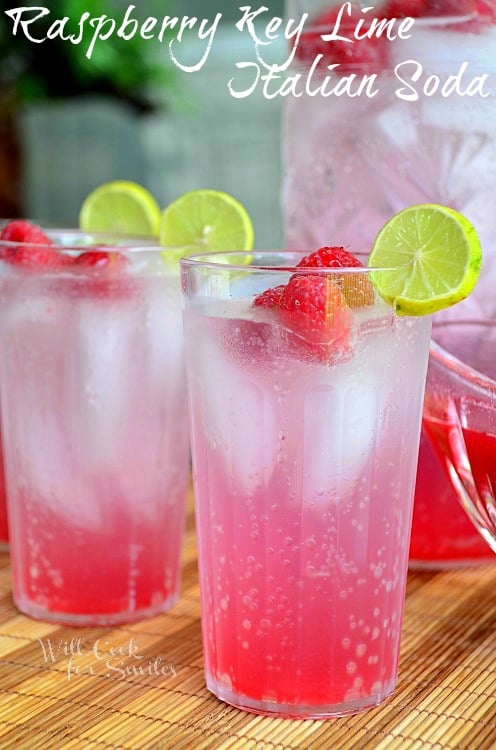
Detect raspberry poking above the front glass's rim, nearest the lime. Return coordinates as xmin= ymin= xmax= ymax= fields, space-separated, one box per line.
xmin=298 ymin=246 xmax=375 ymax=307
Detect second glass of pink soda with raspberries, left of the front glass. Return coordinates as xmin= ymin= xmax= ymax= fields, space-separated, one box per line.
xmin=0 ymin=223 xmax=189 ymax=625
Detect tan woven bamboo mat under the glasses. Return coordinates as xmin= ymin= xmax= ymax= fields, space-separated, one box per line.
xmin=0 ymin=488 xmax=496 ymax=750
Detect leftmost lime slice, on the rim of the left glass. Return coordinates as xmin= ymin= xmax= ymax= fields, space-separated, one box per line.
xmin=79 ymin=180 xmax=160 ymax=237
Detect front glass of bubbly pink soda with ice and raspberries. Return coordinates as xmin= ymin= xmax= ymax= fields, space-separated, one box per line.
xmin=182 ymin=251 xmax=430 ymax=718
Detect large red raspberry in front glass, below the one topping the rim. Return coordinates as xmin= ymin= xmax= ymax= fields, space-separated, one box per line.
xmin=279 ymin=274 xmax=353 ymax=361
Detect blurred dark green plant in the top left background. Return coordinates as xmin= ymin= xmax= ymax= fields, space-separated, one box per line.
xmin=0 ymin=0 xmax=177 ymax=111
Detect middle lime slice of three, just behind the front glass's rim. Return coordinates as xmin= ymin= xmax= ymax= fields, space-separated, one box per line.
xmin=160 ymin=190 xmax=253 ymax=262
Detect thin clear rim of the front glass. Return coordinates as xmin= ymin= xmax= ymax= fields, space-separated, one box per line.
xmin=180 ymin=250 xmax=407 ymax=276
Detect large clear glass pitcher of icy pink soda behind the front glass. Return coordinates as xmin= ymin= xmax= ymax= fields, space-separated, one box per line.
xmin=283 ymin=0 xmax=496 ymax=566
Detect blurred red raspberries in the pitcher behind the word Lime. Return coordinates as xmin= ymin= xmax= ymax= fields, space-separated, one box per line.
xmin=295 ymin=2 xmax=388 ymax=74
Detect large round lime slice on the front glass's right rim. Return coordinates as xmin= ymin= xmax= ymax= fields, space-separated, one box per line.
xmin=368 ymin=204 xmax=482 ymax=315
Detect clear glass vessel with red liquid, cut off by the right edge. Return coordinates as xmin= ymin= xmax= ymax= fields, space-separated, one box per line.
xmin=424 ymin=320 xmax=496 ymax=562
